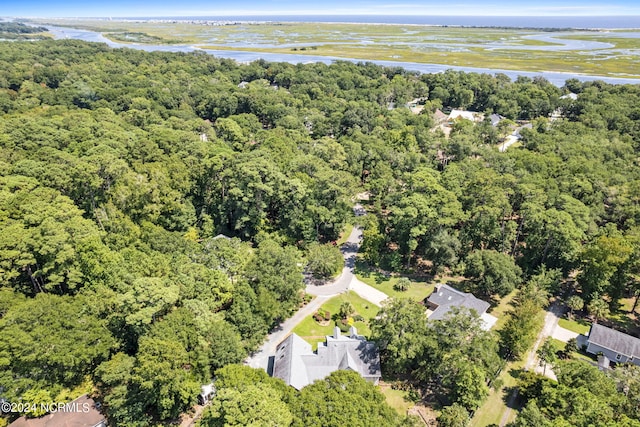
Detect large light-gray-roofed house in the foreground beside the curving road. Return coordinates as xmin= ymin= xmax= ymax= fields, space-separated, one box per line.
xmin=273 ymin=326 xmax=382 ymax=390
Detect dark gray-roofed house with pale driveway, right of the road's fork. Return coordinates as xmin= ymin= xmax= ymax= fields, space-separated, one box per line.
xmin=426 ymin=285 xmax=498 ymax=331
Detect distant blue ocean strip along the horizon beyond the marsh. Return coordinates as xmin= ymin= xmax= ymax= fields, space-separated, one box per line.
xmin=130 ymin=15 xmax=640 ymax=29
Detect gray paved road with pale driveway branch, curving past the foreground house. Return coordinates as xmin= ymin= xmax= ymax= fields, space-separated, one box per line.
xmin=244 ymin=204 xmax=387 ymax=372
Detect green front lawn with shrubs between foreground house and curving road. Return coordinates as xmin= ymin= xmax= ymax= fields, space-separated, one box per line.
xmin=293 ymin=291 xmax=378 ymax=349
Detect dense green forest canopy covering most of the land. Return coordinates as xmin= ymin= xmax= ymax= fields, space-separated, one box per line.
xmin=0 ymin=40 xmax=640 ymax=426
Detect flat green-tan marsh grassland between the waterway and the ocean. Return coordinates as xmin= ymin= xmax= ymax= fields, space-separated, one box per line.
xmin=31 ymin=19 xmax=640 ymax=78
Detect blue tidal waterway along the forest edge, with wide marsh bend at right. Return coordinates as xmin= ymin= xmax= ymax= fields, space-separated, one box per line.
xmin=46 ymin=25 xmax=640 ymax=86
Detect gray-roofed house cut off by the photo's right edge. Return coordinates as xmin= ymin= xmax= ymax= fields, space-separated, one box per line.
xmin=586 ymin=323 xmax=640 ymax=368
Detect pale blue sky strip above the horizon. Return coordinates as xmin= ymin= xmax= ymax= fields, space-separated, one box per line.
xmin=0 ymin=0 xmax=640 ymax=18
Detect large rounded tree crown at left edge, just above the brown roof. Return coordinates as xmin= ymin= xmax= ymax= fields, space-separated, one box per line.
xmin=0 ymin=293 xmax=117 ymax=401
